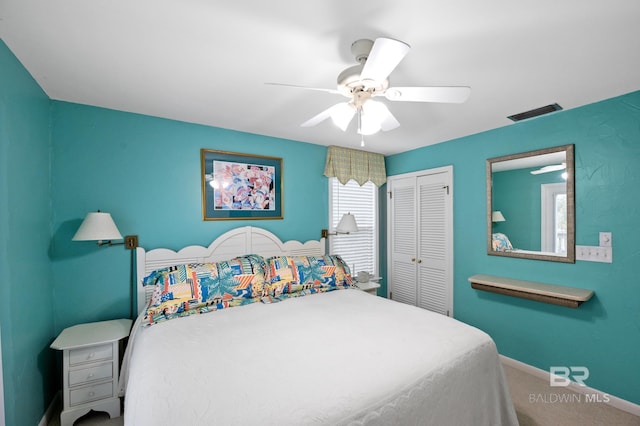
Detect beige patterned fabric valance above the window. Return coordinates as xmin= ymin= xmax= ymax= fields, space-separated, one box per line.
xmin=324 ymin=145 xmax=387 ymax=186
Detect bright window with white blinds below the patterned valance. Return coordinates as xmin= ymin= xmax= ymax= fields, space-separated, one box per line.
xmin=329 ymin=178 xmax=378 ymax=276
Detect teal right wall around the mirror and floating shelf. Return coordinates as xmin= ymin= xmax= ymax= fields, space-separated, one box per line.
xmin=386 ymin=91 xmax=640 ymax=404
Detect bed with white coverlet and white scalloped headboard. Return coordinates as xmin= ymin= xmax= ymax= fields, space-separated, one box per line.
xmin=120 ymin=227 xmax=518 ymax=426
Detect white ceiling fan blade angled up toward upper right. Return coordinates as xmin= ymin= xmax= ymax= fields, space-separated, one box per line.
xmin=360 ymin=38 xmax=410 ymax=84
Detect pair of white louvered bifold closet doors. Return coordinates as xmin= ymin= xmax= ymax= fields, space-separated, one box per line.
xmin=387 ymin=166 xmax=453 ymax=316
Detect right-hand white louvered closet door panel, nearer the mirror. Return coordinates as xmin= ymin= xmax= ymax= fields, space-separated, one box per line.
xmin=417 ymin=173 xmax=453 ymax=315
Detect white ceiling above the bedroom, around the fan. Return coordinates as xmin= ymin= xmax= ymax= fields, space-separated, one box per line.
xmin=0 ymin=0 xmax=640 ymax=154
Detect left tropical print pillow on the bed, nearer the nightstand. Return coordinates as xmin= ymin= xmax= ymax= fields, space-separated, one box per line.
xmin=143 ymin=255 xmax=266 ymax=325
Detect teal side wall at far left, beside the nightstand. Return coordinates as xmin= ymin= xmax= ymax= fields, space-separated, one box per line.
xmin=0 ymin=41 xmax=57 ymax=426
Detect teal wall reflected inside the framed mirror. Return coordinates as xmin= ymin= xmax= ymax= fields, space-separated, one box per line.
xmin=492 ymin=168 xmax=565 ymax=251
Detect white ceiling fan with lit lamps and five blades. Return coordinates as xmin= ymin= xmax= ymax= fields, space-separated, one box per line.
xmin=267 ymin=38 xmax=471 ymax=135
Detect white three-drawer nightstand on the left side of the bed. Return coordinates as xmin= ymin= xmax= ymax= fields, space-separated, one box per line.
xmin=51 ymin=319 xmax=131 ymax=426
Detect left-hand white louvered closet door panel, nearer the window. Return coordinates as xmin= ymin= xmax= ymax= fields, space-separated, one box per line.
xmin=388 ymin=178 xmax=417 ymax=305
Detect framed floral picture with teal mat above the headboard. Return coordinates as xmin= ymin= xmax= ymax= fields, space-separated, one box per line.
xmin=200 ymin=149 xmax=283 ymax=220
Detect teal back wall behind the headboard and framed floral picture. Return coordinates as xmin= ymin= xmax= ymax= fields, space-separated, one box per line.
xmin=51 ymin=102 xmax=329 ymax=332
